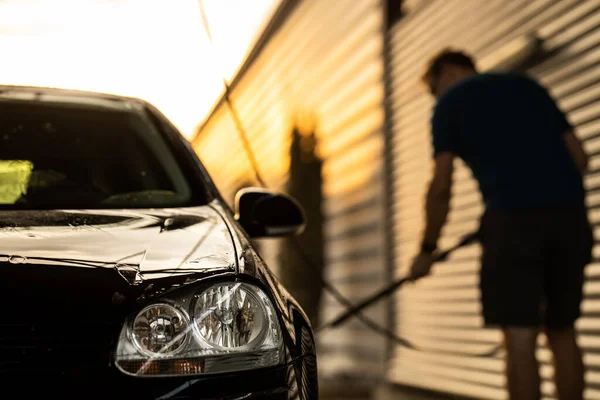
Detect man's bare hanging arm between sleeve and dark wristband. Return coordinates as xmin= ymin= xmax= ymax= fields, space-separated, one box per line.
xmin=423 ymin=152 xmax=454 ymax=247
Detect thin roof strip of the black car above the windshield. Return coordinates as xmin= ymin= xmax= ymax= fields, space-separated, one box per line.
xmin=0 ymin=85 xmax=146 ymax=110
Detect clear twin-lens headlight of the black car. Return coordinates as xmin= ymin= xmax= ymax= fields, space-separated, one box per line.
xmin=115 ymin=283 xmax=283 ymax=376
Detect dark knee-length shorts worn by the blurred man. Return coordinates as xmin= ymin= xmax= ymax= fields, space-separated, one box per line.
xmin=480 ymin=207 xmax=594 ymax=329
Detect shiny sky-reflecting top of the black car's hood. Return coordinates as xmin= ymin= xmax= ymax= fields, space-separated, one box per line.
xmin=0 ymin=206 xmax=236 ymax=284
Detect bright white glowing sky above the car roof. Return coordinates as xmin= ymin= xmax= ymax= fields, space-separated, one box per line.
xmin=0 ymin=0 xmax=279 ymax=138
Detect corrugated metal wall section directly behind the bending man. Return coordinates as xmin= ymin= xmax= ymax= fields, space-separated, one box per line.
xmin=387 ymin=0 xmax=600 ymax=399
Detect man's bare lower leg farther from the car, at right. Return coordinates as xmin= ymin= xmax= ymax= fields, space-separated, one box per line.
xmin=546 ymin=327 xmax=584 ymax=400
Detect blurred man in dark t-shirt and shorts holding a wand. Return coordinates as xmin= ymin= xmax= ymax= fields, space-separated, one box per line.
xmin=411 ymin=50 xmax=594 ymax=400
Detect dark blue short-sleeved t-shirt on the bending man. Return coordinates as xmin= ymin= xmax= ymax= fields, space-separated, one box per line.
xmin=432 ymin=74 xmax=585 ymax=209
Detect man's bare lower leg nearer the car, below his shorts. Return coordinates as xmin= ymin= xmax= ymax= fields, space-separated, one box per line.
xmin=502 ymin=327 xmax=540 ymax=400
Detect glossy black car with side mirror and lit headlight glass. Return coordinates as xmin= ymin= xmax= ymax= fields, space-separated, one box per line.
xmin=0 ymin=86 xmax=318 ymax=399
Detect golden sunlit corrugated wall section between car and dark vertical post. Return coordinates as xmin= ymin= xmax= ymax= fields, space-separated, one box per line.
xmin=193 ymin=0 xmax=385 ymax=377
